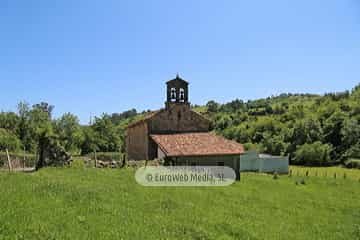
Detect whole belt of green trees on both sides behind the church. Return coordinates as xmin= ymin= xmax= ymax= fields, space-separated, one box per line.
xmin=0 ymin=85 xmax=360 ymax=167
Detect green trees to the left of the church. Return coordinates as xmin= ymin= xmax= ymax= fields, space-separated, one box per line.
xmin=0 ymin=102 xmax=139 ymax=167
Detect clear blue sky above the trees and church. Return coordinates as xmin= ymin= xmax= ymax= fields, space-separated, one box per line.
xmin=0 ymin=0 xmax=360 ymax=123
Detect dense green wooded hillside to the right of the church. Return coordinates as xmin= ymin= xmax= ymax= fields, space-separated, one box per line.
xmin=204 ymin=85 xmax=360 ymax=165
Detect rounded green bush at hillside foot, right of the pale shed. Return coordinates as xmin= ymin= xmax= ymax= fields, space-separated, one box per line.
xmin=294 ymin=141 xmax=332 ymax=165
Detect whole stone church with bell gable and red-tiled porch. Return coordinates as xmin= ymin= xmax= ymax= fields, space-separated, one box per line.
xmin=126 ymin=75 xmax=244 ymax=178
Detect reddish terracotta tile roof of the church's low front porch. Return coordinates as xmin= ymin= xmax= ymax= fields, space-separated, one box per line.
xmin=150 ymin=133 xmax=244 ymax=157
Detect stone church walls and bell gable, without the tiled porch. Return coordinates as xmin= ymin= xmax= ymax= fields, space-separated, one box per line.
xmin=126 ymin=76 xmax=210 ymax=160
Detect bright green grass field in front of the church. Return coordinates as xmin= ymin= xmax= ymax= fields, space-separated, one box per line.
xmin=0 ymin=168 xmax=360 ymax=239
